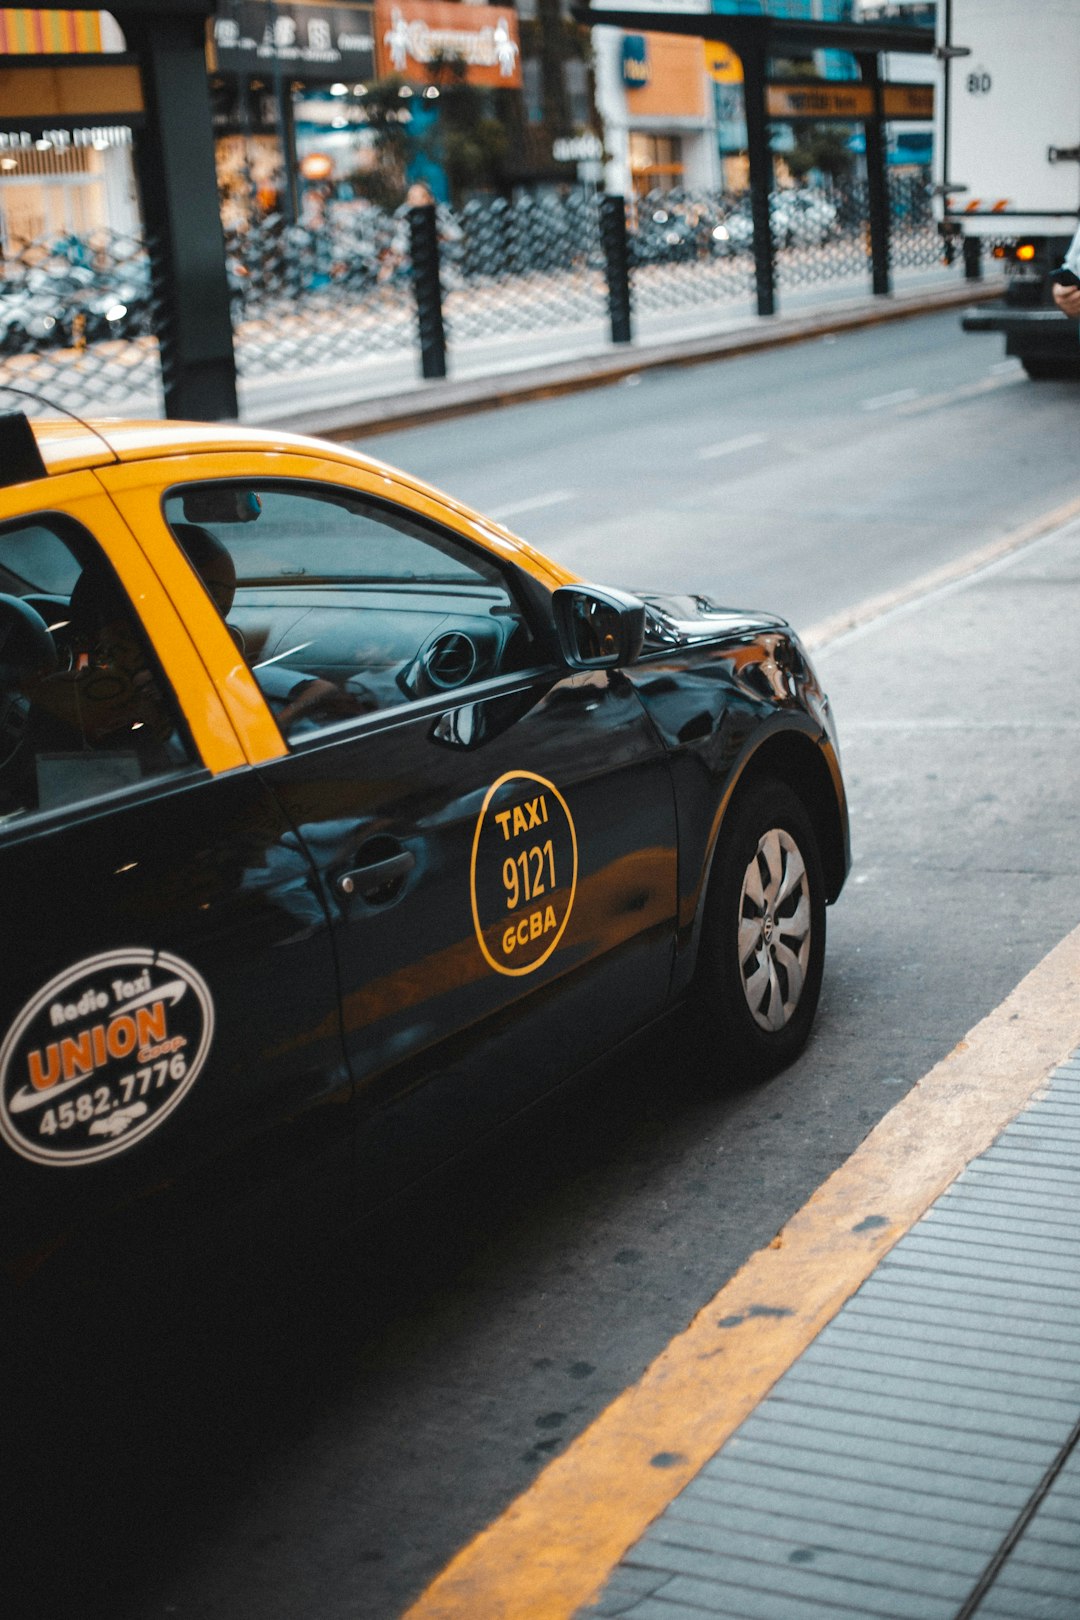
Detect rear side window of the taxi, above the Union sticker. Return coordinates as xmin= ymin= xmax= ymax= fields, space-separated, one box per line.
xmin=0 ymin=517 xmax=194 ymax=833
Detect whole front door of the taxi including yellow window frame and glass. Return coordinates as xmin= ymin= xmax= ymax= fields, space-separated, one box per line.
xmin=102 ymin=449 xmax=677 ymax=1200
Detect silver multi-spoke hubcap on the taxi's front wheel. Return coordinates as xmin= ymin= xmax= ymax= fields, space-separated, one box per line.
xmin=738 ymin=826 xmax=810 ymax=1032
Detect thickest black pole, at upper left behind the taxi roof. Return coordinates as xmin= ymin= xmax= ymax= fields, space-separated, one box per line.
xmin=123 ymin=6 xmax=238 ymax=421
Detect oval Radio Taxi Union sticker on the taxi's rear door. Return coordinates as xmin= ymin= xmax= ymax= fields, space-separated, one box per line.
xmin=0 ymin=948 xmax=214 ymax=1165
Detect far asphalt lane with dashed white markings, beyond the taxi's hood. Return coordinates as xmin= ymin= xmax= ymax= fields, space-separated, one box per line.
xmin=361 ymin=313 xmax=1075 ymax=629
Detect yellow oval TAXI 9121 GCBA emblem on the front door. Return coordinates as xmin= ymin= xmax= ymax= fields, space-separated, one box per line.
xmin=470 ymin=771 xmax=578 ymax=977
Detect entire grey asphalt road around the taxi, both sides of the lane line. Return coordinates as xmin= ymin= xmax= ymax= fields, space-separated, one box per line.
xmin=16 ymin=316 xmax=1080 ymax=1620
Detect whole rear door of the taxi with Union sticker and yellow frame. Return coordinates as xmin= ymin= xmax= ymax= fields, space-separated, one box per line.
xmin=0 ymin=473 xmax=351 ymax=1259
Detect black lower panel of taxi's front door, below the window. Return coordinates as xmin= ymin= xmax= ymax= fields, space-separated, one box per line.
xmin=250 ymin=672 xmax=675 ymax=1197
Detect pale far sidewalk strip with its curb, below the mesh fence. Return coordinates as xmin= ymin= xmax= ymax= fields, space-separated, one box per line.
xmin=240 ymin=271 xmax=1006 ymax=441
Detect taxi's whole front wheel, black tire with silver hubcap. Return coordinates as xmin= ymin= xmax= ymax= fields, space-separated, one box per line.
xmin=696 ymin=779 xmax=826 ymax=1084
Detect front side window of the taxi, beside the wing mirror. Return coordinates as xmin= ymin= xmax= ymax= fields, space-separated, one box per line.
xmin=165 ymin=481 xmax=533 ymax=740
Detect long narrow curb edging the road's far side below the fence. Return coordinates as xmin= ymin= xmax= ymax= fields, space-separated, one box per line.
xmin=261 ymin=280 xmax=1004 ymax=442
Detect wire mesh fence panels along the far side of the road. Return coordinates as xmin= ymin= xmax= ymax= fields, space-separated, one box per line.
xmin=0 ymin=177 xmax=963 ymax=415
